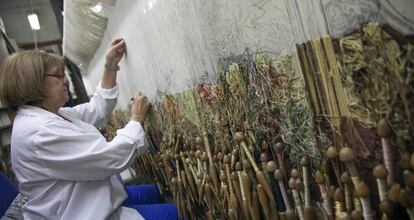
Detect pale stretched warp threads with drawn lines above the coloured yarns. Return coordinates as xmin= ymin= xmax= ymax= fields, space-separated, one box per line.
xmin=80 ymin=0 xmax=413 ymax=108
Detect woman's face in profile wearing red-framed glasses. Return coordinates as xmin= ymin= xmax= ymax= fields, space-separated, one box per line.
xmin=43 ymin=67 xmax=69 ymax=110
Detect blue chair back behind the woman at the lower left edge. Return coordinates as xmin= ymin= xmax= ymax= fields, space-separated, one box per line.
xmin=0 ymin=172 xmax=19 ymax=217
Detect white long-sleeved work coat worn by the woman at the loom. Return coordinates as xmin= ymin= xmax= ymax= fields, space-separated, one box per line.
xmin=11 ymin=85 xmax=145 ymax=220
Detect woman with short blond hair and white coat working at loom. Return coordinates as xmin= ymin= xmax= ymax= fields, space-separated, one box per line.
xmin=0 ymin=39 xmax=177 ymax=220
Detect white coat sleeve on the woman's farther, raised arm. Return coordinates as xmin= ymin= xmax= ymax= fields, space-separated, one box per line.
xmin=60 ymin=83 xmax=119 ymax=128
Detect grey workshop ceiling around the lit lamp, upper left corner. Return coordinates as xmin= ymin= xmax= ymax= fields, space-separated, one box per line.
xmin=0 ymin=0 xmax=63 ymax=54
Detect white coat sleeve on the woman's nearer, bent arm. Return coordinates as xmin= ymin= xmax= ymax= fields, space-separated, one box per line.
xmin=33 ymin=121 xmax=145 ymax=181
